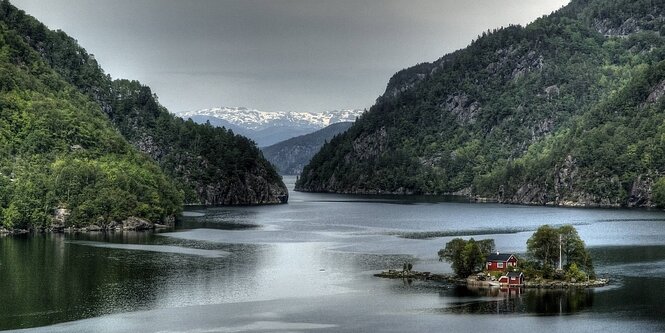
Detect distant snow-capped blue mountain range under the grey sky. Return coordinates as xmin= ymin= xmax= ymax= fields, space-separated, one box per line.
xmin=176 ymin=107 xmax=364 ymax=147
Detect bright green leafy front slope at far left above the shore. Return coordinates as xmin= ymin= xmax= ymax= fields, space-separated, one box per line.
xmin=0 ymin=22 xmax=183 ymax=230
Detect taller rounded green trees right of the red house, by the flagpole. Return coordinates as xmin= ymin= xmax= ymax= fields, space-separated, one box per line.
xmin=527 ymin=225 xmax=595 ymax=280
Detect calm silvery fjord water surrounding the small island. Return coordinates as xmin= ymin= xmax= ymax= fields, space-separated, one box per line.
xmin=0 ymin=178 xmax=665 ymax=332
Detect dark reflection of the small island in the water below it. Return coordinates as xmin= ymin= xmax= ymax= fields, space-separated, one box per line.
xmin=443 ymin=286 xmax=594 ymax=316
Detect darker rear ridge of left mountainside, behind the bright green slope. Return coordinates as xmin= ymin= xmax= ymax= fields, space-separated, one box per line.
xmin=0 ymin=0 xmax=288 ymax=205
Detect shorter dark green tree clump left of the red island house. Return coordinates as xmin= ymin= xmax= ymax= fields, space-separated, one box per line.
xmin=438 ymin=238 xmax=494 ymax=277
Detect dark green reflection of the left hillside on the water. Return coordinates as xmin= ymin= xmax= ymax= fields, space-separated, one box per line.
xmin=0 ymin=232 xmax=266 ymax=330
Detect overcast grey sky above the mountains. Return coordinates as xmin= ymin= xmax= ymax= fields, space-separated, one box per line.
xmin=10 ymin=0 xmax=568 ymax=112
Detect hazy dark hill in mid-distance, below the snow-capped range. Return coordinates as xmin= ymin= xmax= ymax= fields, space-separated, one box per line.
xmin=261 ymin=122 xmax=353 ymax=175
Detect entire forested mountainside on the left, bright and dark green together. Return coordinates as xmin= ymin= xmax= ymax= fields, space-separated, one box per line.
xmin=0 ymin=0 xmax=288 ymax=229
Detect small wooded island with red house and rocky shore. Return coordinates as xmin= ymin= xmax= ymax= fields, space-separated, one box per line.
xmin=375 ymin=225 xmax=609 ymax=289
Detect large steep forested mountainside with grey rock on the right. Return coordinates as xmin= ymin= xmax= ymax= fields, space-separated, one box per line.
xmin=296 ymin=0 xmax=665 ymax=206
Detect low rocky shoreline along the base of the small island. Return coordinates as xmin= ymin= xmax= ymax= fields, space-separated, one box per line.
xmin=374 ymin=269 xmax=610 ymax=289
